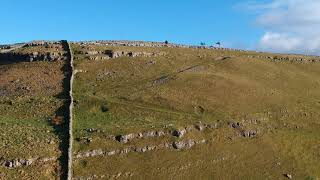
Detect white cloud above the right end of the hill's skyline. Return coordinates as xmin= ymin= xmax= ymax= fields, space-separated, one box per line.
xmin=241 ymin=0 xmax=320 ymax=54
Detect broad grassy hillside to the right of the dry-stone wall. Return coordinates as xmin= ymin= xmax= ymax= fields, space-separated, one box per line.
xmin=73 ymin=44 xmax=320 ymax=179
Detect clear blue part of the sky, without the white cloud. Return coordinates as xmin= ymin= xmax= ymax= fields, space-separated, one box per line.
xmin=0 ymin=0 xmax=261 ymax=47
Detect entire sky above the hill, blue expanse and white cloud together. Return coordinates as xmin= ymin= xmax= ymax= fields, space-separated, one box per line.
xmin=0 ymin=0 xmax=320 ymax=54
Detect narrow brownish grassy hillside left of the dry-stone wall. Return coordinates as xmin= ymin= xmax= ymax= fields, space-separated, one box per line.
xmin=0 ymin=45 xmax=68 ymax=179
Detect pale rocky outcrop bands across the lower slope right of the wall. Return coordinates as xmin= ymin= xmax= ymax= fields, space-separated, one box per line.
xmin=74 ymin=118 xmax=267 ymax=160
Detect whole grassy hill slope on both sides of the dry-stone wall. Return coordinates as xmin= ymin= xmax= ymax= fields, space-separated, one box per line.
xmin=0 ymin=41 xmax=320 ymax=179
